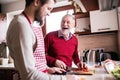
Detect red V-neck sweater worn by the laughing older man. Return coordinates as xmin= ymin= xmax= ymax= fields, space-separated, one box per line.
xmin=45 ymin=31 xmax=80 ymax=67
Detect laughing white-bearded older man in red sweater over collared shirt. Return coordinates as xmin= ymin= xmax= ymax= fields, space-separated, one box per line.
xmin=44 ymin=14 xmax=86 ymax=69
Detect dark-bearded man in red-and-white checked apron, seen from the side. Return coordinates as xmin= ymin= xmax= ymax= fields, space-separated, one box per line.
xmin=7 ymin=0 xmax=79 ymax=80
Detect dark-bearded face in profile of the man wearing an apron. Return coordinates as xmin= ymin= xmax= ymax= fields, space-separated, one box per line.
xmin=35 ymin=0 xmax=54 ymax=25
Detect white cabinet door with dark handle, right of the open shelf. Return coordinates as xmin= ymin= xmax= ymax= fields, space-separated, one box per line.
xmin=90 ymin=9 xmax=118 ymax=33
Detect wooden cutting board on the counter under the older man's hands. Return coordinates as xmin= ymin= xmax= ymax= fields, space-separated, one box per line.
xmin=67 ymin=68 xmax=95 ymax=75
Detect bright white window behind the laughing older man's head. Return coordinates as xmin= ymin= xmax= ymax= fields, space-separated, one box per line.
xmin=46 ymin=9 xmax=74 ymax=33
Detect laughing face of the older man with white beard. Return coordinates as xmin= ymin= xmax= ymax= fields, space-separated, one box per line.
xmin=61 ymin=16 xmax=75 ymax=34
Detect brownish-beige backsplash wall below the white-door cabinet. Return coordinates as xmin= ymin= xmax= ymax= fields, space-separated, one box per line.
xmin=77 ymin=32 xmax=118 ymax=53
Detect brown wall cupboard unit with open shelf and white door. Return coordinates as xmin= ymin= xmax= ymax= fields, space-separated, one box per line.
xmin=74 ymin=0 xmax=118 ymax=35
